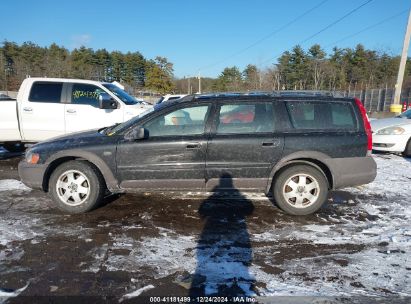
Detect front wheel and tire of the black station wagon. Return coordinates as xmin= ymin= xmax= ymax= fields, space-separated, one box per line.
xmin=49 ymin=161 xmax=106 ymax=214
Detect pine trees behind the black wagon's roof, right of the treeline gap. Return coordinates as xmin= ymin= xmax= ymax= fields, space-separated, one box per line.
xmin=197 ymin=44 xmax=411 ymax=91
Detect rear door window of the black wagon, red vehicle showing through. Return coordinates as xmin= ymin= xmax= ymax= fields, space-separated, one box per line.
xmin=217 ymin=102 xmax=274 ymax=134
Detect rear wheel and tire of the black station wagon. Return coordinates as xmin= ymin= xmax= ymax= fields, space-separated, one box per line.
xmin=273 ymin=165 xmax=328 ymax=215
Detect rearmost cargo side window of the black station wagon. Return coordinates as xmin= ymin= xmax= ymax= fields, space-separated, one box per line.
xmin=286 ymin=101 xmax=357 ymax=131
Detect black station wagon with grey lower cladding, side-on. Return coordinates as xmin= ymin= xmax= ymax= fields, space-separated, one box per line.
xmin=19 ymin=92 xmax=376 ymax=215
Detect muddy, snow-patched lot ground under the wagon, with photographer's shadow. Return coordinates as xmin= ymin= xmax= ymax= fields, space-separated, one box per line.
xmin=0 ymin=150 xmax=411 ymax=303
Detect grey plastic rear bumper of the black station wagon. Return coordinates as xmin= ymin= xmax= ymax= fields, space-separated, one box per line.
xmin=325 ymin=156 xmax=377 ymax=189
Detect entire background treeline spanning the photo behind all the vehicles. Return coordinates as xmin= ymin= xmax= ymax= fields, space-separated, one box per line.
xmin=0 ymin=41 xmax=411 ymax=94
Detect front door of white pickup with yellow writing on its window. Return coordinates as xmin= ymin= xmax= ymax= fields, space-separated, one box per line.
xmin=64 ymin=83 xmax=123 ymax=133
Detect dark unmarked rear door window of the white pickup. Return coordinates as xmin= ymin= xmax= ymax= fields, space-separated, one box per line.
xmin=29 ymin=82 xmax=63 ymax=103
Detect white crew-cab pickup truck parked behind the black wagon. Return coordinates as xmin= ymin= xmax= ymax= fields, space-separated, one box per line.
xmin=0 ymin=78 xmax=151 ymax=150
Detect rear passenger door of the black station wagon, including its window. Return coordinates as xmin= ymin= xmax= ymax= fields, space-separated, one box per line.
xmin=206 ymin=100 xmax=284 ymax=191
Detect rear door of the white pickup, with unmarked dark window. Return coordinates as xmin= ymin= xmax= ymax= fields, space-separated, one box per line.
xmin=18 ymin=81 xmax=65 ymax=142
